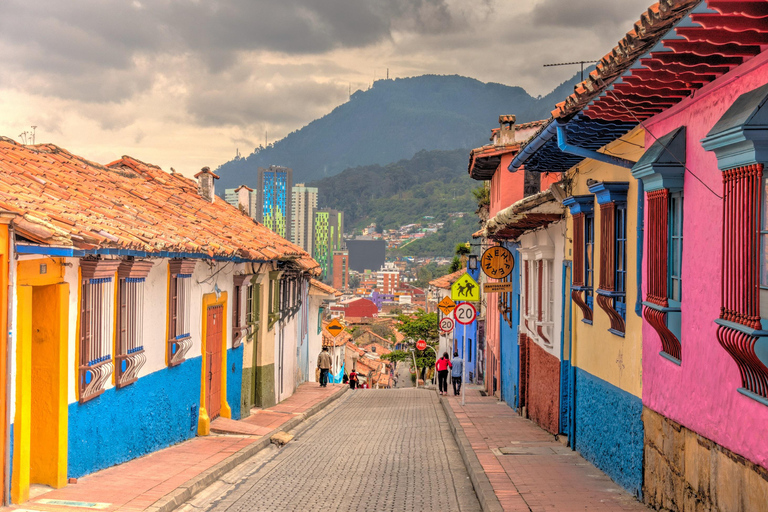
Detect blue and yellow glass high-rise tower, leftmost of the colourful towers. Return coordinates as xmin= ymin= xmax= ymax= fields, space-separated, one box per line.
xmin=253 ymin=165 xmax=293 ymax=240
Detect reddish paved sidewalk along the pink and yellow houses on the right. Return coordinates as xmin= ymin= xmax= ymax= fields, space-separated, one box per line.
xmin=441 ymin=388 xmax=648 ymax=512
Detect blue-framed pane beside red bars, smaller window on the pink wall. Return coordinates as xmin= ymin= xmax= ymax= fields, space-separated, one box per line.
xmin=667 ymin=191 xmax=683 ymax=340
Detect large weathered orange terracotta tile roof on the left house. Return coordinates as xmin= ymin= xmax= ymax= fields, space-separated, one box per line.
xmin=0 ymin=137 xmax=319 ymax=274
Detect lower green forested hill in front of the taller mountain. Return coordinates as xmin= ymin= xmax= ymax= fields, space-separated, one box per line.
xmin=308 ymin=149 xmax=479 ymax=231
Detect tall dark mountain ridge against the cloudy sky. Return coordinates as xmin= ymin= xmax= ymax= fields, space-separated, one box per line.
xmin=216 ymin=71 xmax=578 ymax=188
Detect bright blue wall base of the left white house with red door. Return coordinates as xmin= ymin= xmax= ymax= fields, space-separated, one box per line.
xmin=68 ymin=349 xmax=201 ymax=478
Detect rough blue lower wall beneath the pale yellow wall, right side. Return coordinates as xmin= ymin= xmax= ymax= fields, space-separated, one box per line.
xmin=575 ymin=368 xmax=643 ymax=499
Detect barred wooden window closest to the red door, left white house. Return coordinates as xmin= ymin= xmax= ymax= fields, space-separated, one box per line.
xmin=167 ymin=260 xmax=195 ymax=366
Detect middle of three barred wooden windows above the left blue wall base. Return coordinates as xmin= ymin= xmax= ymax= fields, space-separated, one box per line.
xmin=115 ymin=260 xmax=152 ymax=388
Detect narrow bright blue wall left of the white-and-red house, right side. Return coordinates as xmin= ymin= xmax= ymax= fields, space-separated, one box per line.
xmin=499 ymin=243 xmax=520 ymax=409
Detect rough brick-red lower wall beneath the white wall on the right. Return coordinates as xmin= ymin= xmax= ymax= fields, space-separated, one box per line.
xmin=524 ymin=336 xmax=560 ymax=434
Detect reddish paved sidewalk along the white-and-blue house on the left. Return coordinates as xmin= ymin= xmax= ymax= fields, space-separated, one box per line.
xmin=8 ymin=382 xmax=347 ymax=512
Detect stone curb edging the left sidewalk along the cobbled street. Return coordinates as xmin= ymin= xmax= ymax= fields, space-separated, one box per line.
xmin=145 ymin=386 xmax=349 ymax=512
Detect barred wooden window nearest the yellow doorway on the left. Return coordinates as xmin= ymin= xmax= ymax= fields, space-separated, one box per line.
xmin=78 ymin=260 xmax=120 ymax=403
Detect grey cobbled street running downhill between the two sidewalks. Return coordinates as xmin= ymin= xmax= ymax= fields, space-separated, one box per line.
xmin=179 ymin=388 xmax=480 ymax=512
